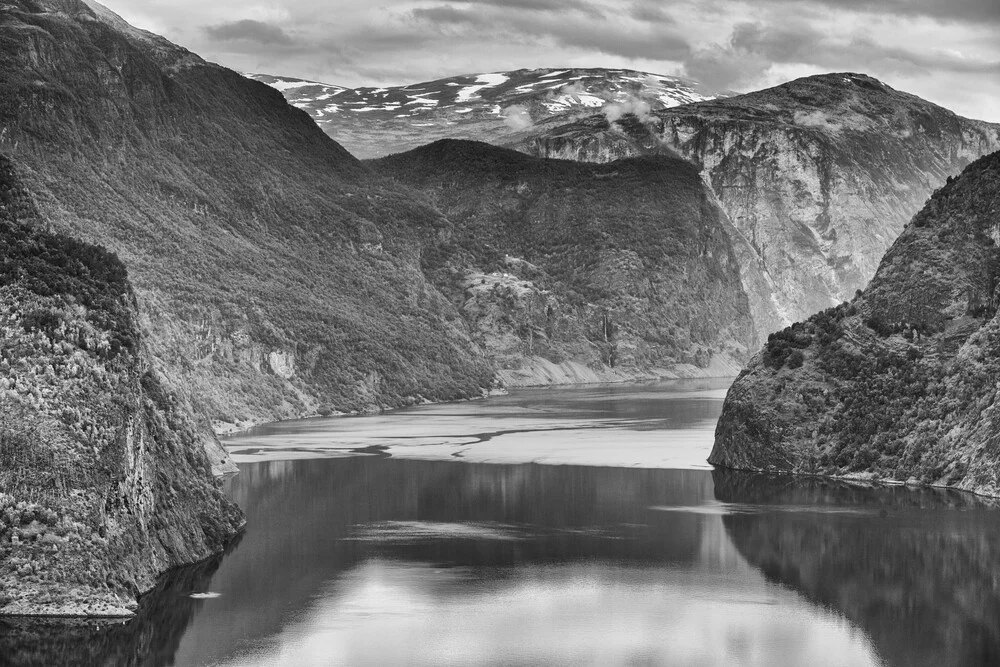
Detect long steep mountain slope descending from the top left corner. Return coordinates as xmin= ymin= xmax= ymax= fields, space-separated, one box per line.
xmin=0 ymin=0 xmax=492 ymax=434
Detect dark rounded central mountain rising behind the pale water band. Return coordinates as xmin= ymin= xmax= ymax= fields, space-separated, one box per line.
xmin=371 ymin=140 xmax=757 ymax=385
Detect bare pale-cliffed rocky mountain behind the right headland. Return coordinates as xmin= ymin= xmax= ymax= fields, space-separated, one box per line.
xmin=512 ymin=74 xmax=1000 ymax=329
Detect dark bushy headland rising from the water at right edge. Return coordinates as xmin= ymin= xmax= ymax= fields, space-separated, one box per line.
xmin=709 ymin=153 xmax=1000 ymax=495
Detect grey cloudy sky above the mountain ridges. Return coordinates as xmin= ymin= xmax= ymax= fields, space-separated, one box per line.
xmin=104 ymin=0 xmax=1000 ymax=122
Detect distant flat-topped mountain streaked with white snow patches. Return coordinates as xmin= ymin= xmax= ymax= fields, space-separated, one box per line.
xmin=247 ymin=68 xmax=719 ymax=158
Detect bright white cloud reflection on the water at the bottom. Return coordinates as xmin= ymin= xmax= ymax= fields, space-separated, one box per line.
xmin=217 ymin=560 xmax=880 ymax=667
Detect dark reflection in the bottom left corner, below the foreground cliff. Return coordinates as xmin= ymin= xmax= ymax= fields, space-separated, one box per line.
xmin=0 ymin=537 xmax=240 ymax=667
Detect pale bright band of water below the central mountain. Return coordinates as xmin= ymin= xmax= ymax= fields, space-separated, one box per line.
xmin=224 ymin=379 xmax=731 ymax=470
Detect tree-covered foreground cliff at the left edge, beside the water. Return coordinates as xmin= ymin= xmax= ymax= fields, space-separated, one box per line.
xmin=0 ymin=157 xmax=243 ymax=616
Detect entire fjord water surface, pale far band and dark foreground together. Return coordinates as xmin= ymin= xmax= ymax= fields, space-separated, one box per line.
xmin=0 ymin=382 xmax=1000 ymax=666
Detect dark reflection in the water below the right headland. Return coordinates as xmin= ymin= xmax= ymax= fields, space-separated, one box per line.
xmin=713 ymin=470 xmax=1000 ymax=667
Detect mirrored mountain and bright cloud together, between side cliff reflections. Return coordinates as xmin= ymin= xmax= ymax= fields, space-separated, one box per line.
xmin=166 ymin=457 xmax=878 ymax=665
